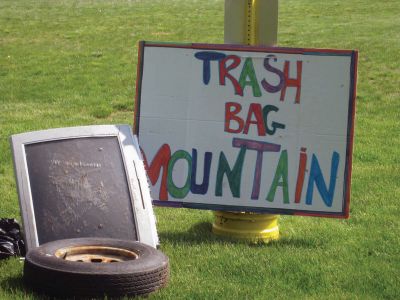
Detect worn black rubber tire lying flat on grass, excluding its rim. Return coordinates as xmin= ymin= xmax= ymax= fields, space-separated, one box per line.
xmin=24 ymin=238 xmax=169 ymax=297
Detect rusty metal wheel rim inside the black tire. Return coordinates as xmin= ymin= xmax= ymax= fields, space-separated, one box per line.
xmin=55 ymin=246 xmax=139 ymax=263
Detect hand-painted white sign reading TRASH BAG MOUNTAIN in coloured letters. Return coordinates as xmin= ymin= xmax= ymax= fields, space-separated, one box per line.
xmin=135 ymin=42 xmax=357 ymax=218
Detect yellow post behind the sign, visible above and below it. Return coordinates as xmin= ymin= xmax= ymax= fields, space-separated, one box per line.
xmin=212 ymin=0 xmax=279 ymax=242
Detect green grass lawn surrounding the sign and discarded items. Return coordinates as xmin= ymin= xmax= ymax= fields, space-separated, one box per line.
xmin=0 ymin=0 xmax=400 ymax=299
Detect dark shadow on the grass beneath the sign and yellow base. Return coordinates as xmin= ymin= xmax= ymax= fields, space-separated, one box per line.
xmin=159 ymin=222 xmax=324 ymax=249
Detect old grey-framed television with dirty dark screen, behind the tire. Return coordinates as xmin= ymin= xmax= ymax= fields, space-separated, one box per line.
xmin=11 ymin=125 xmax=158 ymax=250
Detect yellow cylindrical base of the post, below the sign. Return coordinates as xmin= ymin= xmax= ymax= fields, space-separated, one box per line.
xmin=212 ymin=211 xmax=279 ymax=243
